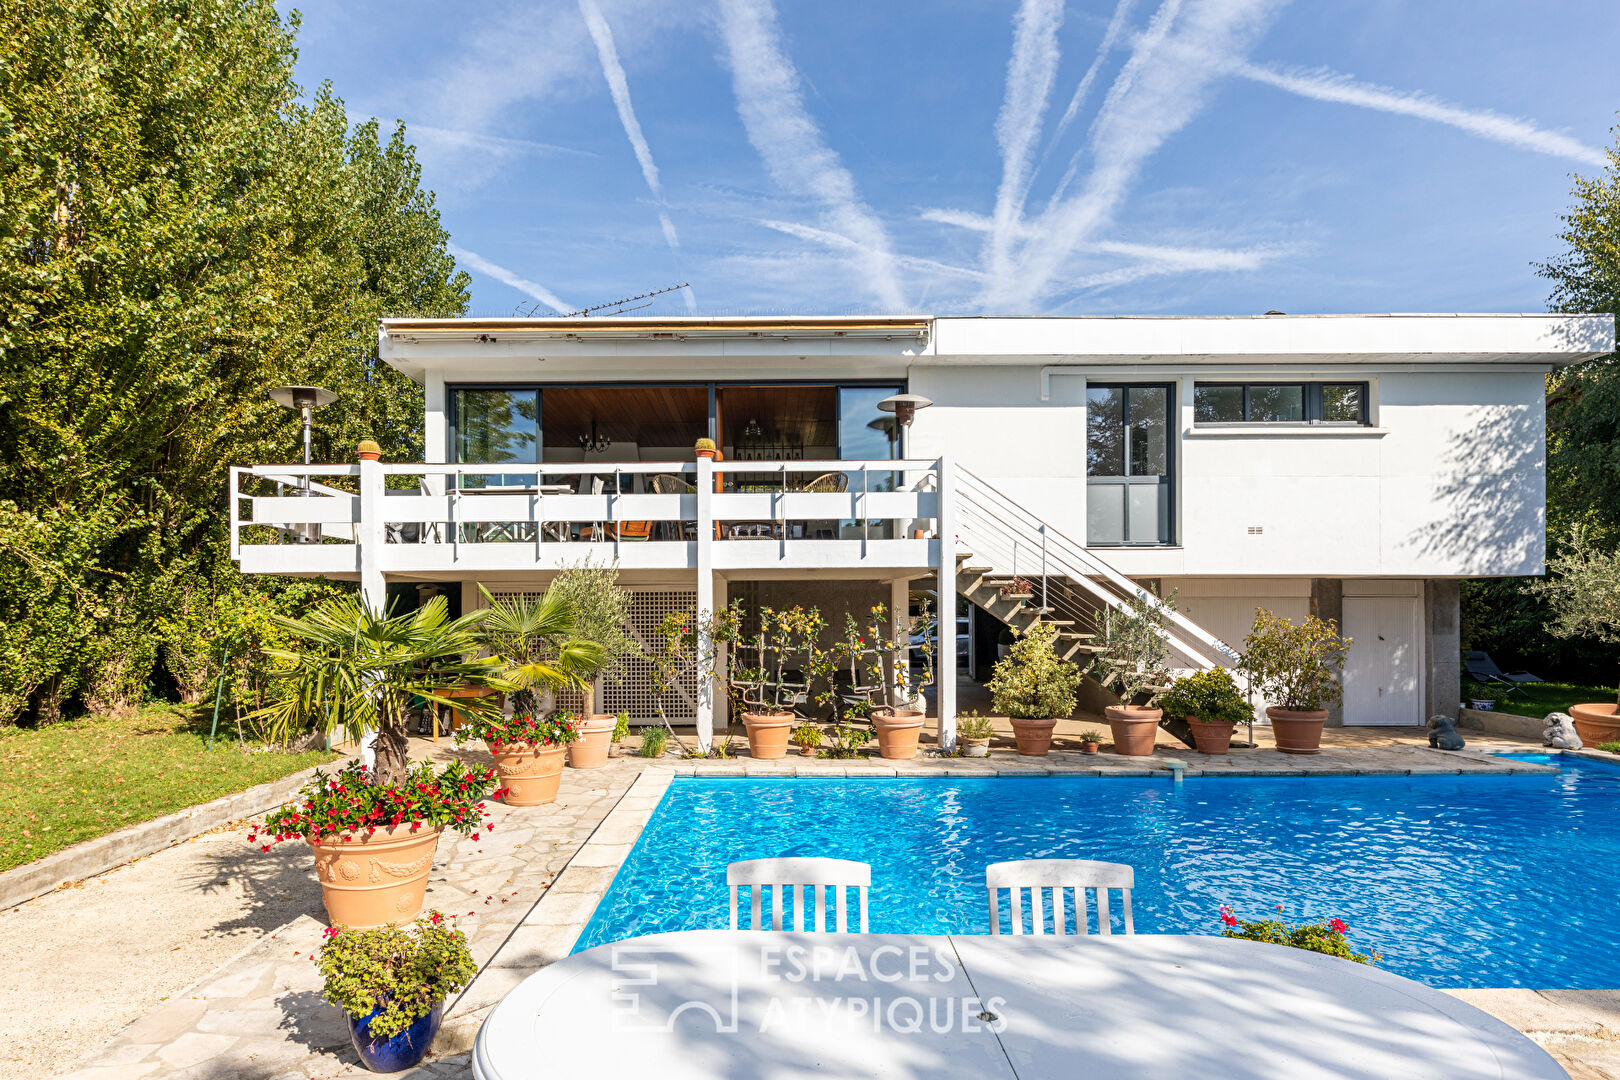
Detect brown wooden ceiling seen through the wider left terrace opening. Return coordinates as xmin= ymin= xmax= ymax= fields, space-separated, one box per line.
xmin=539 ymin=387 xmax=708 ymax=447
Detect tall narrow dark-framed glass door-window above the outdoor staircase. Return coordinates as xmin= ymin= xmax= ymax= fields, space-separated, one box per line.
xmin=1085 ymin=384 xmax=1173 ymax=546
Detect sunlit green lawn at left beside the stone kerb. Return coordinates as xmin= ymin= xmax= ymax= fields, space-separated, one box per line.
xmin=0 ymin=704 xmax=337 ymax=870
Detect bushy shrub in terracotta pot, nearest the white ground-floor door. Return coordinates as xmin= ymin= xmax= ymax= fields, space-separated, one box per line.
xmin=1241 ymin=607 xmax=1351 ymax=755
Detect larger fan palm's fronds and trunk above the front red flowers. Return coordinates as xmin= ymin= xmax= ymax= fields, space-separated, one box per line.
xmin=253 ymin=596 xmax=507 ymax=784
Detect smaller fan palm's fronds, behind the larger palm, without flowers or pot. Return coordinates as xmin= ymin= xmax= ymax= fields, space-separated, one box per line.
xmin=478 ymin=585 xmax=603 ymax=714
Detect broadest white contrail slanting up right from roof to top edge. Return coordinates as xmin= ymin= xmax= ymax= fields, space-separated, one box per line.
xmin=982 ymin=0 xmax=1280 ymax=313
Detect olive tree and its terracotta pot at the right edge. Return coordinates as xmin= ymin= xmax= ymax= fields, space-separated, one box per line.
xmin=1531 ymin=526 xmax=1620 ymax=746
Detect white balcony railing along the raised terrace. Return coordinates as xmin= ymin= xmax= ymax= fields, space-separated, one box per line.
xmin=230 ymin=460 xmax=938 ymax=573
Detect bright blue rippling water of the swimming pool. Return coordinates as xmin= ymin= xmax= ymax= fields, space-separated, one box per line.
xmin=575 ymin=755 xmax=1620 ymax=988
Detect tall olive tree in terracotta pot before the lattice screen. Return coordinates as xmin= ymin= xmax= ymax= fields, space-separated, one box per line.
xmin=546 ymin=560 xmax=645 ymax=769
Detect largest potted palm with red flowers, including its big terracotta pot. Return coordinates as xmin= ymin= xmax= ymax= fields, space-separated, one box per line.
xmin=253 ymin=596 xmax=507 ymax=926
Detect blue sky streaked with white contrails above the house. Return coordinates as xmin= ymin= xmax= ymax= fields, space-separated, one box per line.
xmin=284 ymin=0 xmax=1620 ymax=316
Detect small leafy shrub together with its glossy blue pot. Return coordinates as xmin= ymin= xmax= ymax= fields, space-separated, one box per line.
xmin=318 ymin=912 xmax=478 ymax=1072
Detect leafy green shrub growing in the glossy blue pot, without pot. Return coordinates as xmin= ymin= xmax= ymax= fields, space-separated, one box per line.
xmin=319 ymin=912 xmax=478 ymax=1038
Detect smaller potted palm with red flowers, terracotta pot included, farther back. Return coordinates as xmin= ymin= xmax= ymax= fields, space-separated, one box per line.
xmin=476 ymin=585 xmax=612 ymax=790
